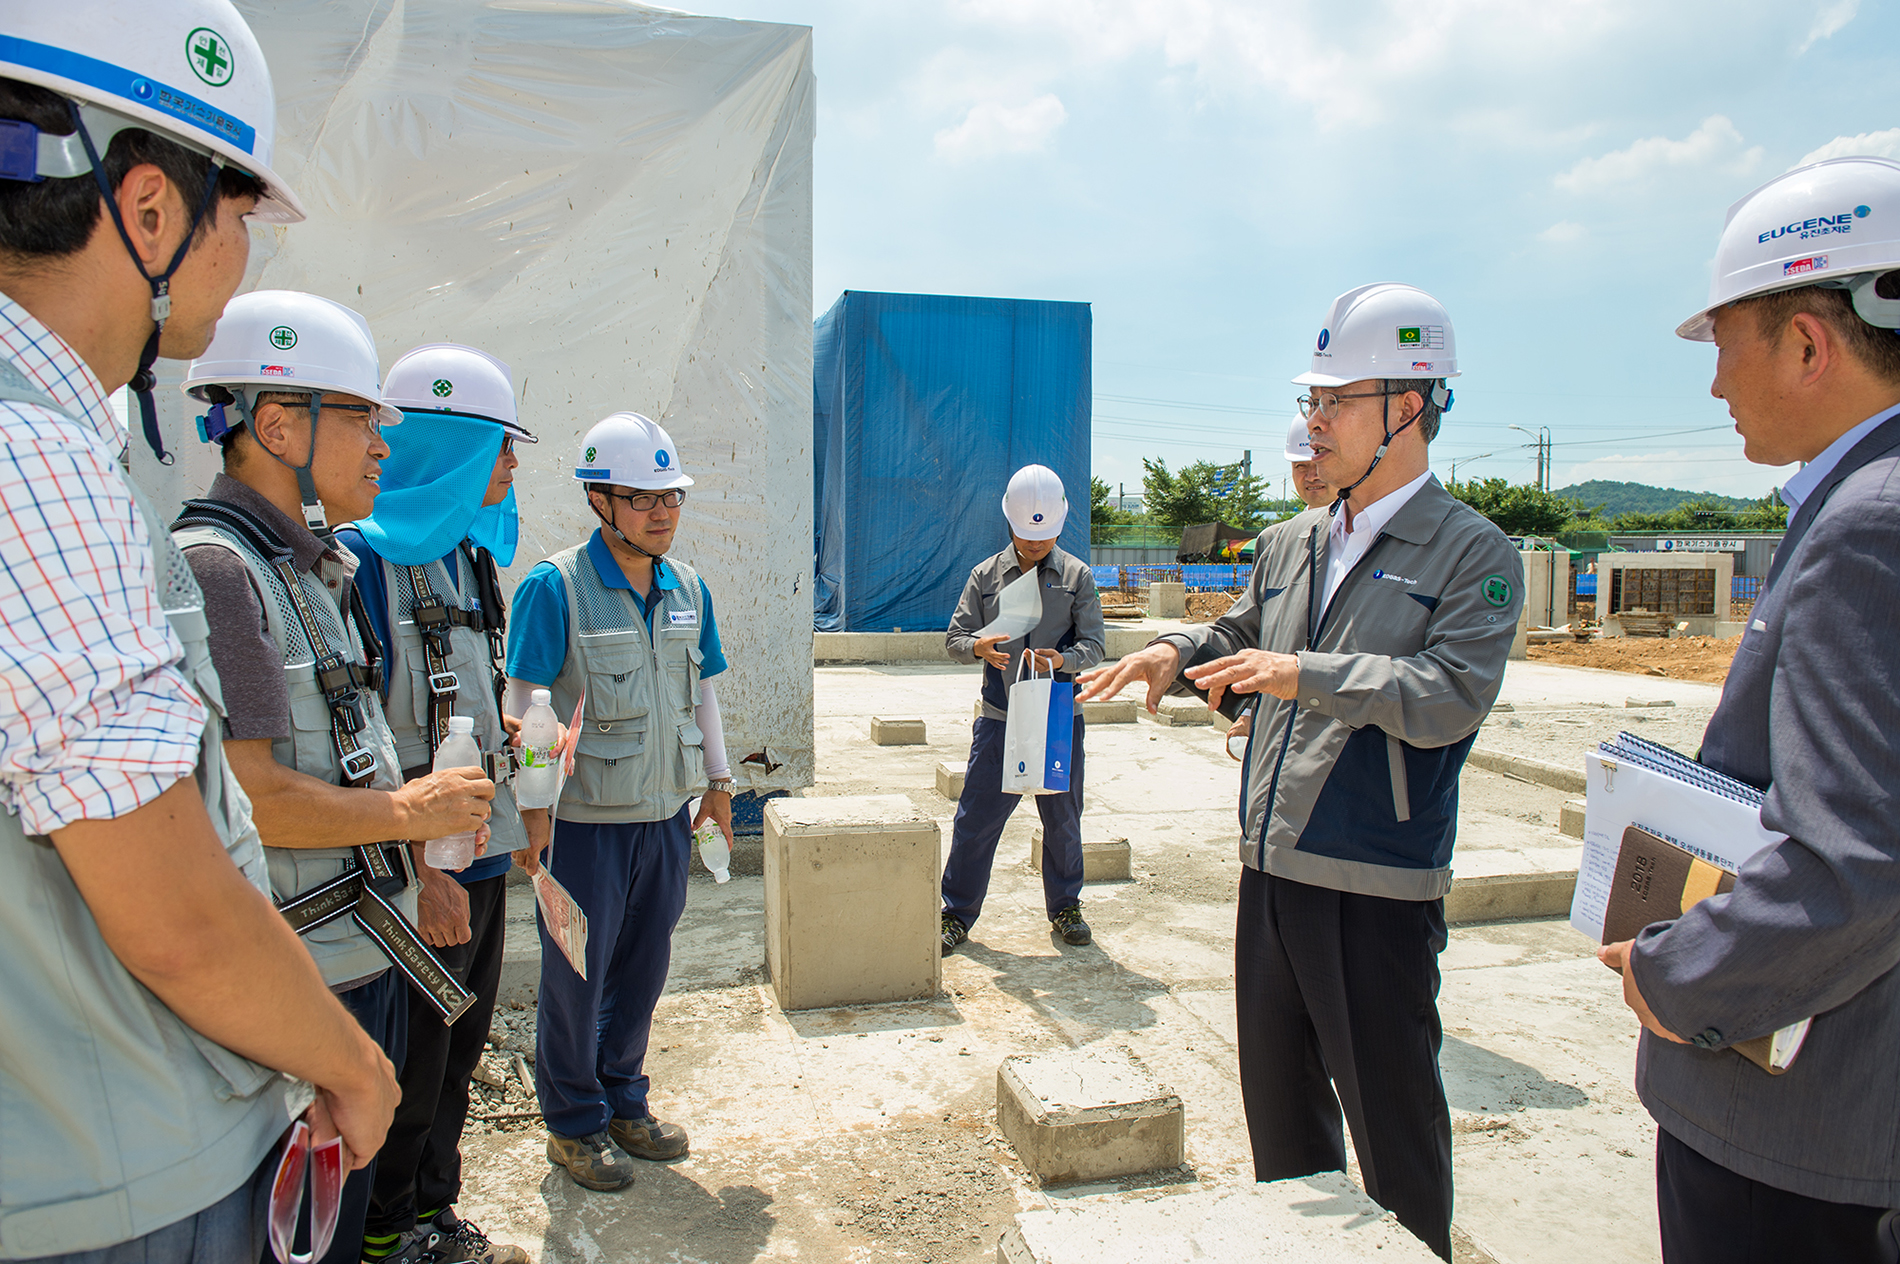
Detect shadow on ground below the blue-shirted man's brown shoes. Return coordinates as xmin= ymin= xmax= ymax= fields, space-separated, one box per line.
xmin=540 ymin=1163 xmax=779 ymax=1264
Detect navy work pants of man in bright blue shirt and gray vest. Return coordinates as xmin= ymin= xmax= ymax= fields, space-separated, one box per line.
xmin=534 ymin=808 xmax=692 ymax=1137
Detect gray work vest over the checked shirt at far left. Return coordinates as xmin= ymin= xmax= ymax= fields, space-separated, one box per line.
xmin=0 ymin=359 xmax=291 ymax=1260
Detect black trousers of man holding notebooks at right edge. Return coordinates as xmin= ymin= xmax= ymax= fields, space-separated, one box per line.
xmin=1657 ymin=1129 xmax=1900 ymax=1264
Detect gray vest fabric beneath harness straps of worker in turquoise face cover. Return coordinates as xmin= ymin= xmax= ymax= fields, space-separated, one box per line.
xmin=382 ymin=553 xmax=528 ymax=855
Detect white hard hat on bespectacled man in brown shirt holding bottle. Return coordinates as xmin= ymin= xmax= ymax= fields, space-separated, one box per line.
xmin=184 ymin=289 xmax=403 ymax=439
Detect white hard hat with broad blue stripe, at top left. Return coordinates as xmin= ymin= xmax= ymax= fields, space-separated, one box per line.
xmin=0 ymin=0 xmax=304 ymax=224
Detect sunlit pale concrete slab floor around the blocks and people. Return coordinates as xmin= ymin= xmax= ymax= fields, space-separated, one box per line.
xmin=462 ymin=663 xmax=1664 ymax=1264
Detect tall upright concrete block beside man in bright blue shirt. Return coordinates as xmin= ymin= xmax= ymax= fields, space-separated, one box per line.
xmin=766 ymin=795 xmax=942 ymax=1009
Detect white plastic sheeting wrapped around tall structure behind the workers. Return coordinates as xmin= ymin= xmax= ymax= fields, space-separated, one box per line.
xmin=135 ymin=0 xmax=815 ymax=787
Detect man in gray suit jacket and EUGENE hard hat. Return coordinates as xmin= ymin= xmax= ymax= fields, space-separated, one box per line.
xmin=1602 ymin=158 xmax=1900 ymax=1264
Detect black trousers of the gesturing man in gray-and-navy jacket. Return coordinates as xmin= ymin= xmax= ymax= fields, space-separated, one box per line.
xmin=1233 ymin=869 xmax=1452 ymax=1260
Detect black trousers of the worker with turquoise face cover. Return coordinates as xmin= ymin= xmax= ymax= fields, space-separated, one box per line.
xmin=365 ymin=874 xmax=507 ymax=1237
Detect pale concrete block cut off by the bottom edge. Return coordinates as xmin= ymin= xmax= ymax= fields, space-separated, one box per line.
xmin=996 ymin=1173 xmax=1438 ymax=1264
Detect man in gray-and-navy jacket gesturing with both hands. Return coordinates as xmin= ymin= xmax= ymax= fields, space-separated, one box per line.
xmin=1079 ymin=285 xmax=1524 ymax=1260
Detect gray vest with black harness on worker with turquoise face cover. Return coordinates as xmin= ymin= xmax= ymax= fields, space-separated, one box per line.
xmin=382 ymin=549 xmax=528 ymax=855
